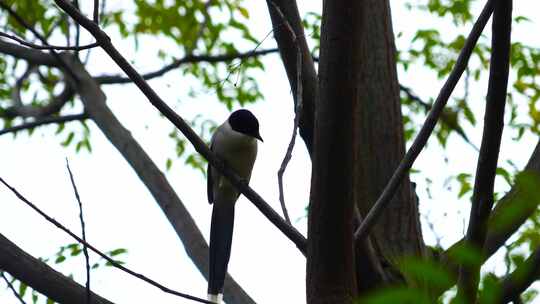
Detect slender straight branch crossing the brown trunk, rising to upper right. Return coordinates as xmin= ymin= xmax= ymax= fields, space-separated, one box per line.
xmin=354 ymin=0 xmax=494 ymax=239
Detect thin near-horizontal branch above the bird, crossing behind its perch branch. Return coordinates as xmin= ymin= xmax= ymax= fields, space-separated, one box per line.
xmin=94 ymin=49 xmax=278 ymax=84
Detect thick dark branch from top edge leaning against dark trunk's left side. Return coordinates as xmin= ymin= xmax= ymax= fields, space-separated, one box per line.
xmin=266 ymin=0 xmax=319 ymax=156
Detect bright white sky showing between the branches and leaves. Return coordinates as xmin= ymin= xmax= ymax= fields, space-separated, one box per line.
xmin=0 ymin=1 xmax=540 ymax=303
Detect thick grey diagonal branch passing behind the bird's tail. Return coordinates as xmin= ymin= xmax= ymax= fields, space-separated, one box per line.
xmin=62 ymin=56 xmax=254 ymax=303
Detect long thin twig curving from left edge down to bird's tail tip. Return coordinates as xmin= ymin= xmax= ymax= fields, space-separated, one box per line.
xmin=0 ymin=177 xmax=214 ymax=304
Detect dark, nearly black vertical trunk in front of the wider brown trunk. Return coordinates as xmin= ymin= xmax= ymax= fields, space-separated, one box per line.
xmin=306 ymin=0 xmax=363 ymax=304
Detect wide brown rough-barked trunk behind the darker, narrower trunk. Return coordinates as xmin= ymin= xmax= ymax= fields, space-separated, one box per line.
xmin=354 ymin=0 xmax=424 ymax=268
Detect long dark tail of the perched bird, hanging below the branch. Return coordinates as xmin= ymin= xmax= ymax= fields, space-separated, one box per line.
xmin=208 ymin=202 xmax=234 ymax=297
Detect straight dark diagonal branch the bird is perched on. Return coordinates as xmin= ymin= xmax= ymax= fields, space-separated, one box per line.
xmin=55 ymin=0 xmax=307 ymax=253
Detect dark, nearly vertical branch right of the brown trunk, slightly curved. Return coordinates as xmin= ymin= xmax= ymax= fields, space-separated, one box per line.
xmin=458 ymin=0 xmax=512 ymax=303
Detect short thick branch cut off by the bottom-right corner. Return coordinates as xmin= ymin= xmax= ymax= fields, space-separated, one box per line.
xmin=498 ymin=248 xmax=540 ymax=304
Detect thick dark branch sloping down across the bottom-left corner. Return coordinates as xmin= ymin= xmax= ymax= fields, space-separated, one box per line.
xmin=0 ymin=234 xmax=112 ymax=304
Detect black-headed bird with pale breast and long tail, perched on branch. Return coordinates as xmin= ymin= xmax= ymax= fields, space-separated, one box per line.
xmin=207 ymin=109 xmax=263 ymax=303
